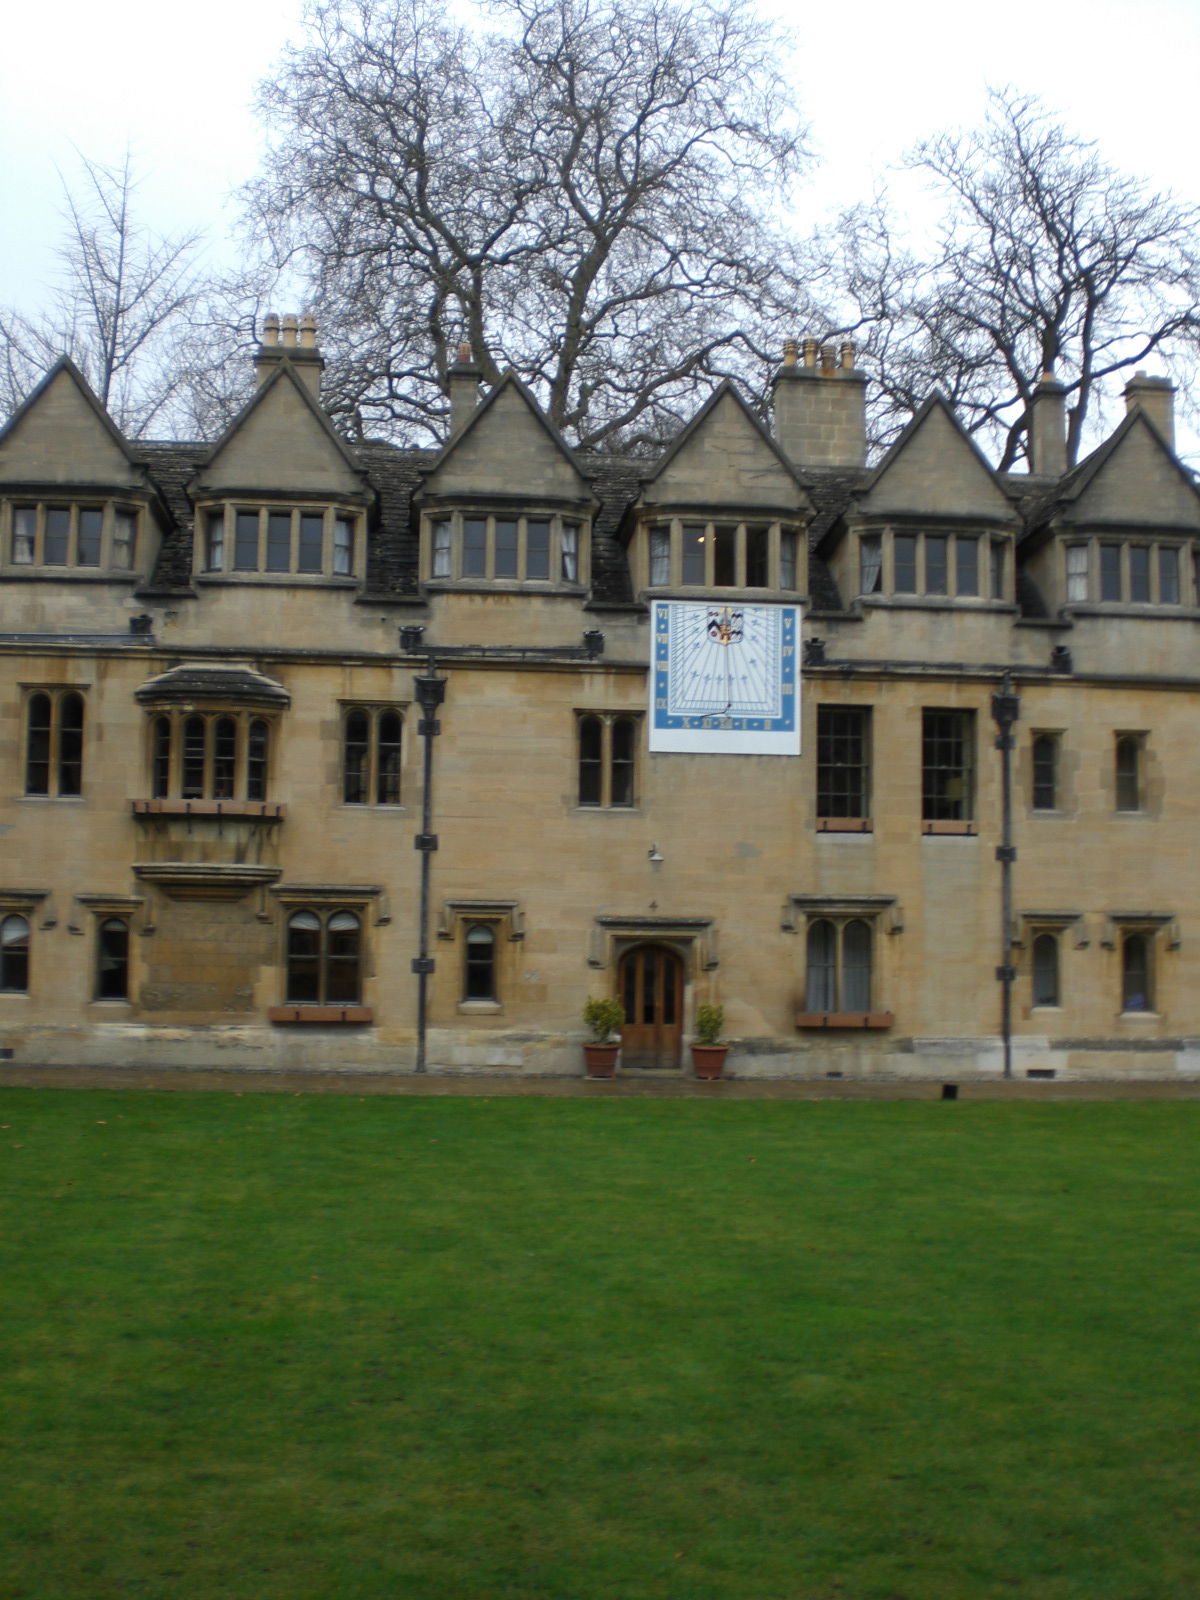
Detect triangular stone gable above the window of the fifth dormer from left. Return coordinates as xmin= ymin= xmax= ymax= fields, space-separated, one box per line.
xmin=861 ymin=395 xmax=1016 ymax=522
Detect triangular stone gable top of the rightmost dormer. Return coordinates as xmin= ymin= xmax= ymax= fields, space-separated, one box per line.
xmin=1064 ymin=411 xmax=1200 ymax=530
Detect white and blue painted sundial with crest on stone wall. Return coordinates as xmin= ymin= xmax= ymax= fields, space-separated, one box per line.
xmin=650 ymin=600 xmax=798 ymax=755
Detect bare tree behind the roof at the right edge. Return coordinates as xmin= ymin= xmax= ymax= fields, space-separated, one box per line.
xmin=874 ymin=90 xmax=1200 ymax=469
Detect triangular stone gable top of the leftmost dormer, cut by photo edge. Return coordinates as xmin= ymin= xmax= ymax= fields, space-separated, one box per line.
xmin=0 ymin=357 xmax=141 ymax=486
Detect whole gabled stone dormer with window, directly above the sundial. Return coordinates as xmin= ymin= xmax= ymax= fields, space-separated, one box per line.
xmin=630 ymin=382 xmax=813 ymax=595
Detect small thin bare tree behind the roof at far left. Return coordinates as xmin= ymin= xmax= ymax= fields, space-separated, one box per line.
xmin=0 ymin=155 xmax=209 ymax=435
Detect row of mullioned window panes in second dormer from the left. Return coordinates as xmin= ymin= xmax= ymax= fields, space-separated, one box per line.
xmin=200 ymin=506 xmax=358 ymax=578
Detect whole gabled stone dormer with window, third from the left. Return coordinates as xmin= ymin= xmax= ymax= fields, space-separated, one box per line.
xmin=419 ymin=363 xmax=597 ymax=592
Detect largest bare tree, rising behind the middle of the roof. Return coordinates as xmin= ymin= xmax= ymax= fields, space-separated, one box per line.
xmin=248 ymin=0 xmax=803 ymax=445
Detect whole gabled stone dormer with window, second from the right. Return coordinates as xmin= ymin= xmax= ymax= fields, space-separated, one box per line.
xmin=827 ymin=395 xmax=1019 ymax=605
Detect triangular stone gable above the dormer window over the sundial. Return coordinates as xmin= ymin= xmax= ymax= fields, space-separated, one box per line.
xmin=643 ymin=382 xmax=808 ymax=510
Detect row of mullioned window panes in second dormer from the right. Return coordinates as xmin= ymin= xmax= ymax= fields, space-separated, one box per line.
xmin=858 ymin=528 xmax=1008 ymax=600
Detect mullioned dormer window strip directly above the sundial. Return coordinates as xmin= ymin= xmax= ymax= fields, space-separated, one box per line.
xmin=645 ymin=518 xmax=800 ymax=590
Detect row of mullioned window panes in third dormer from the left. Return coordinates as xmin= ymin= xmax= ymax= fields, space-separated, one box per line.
xmin=427 ymin=510 xmax=582 ymax=584
